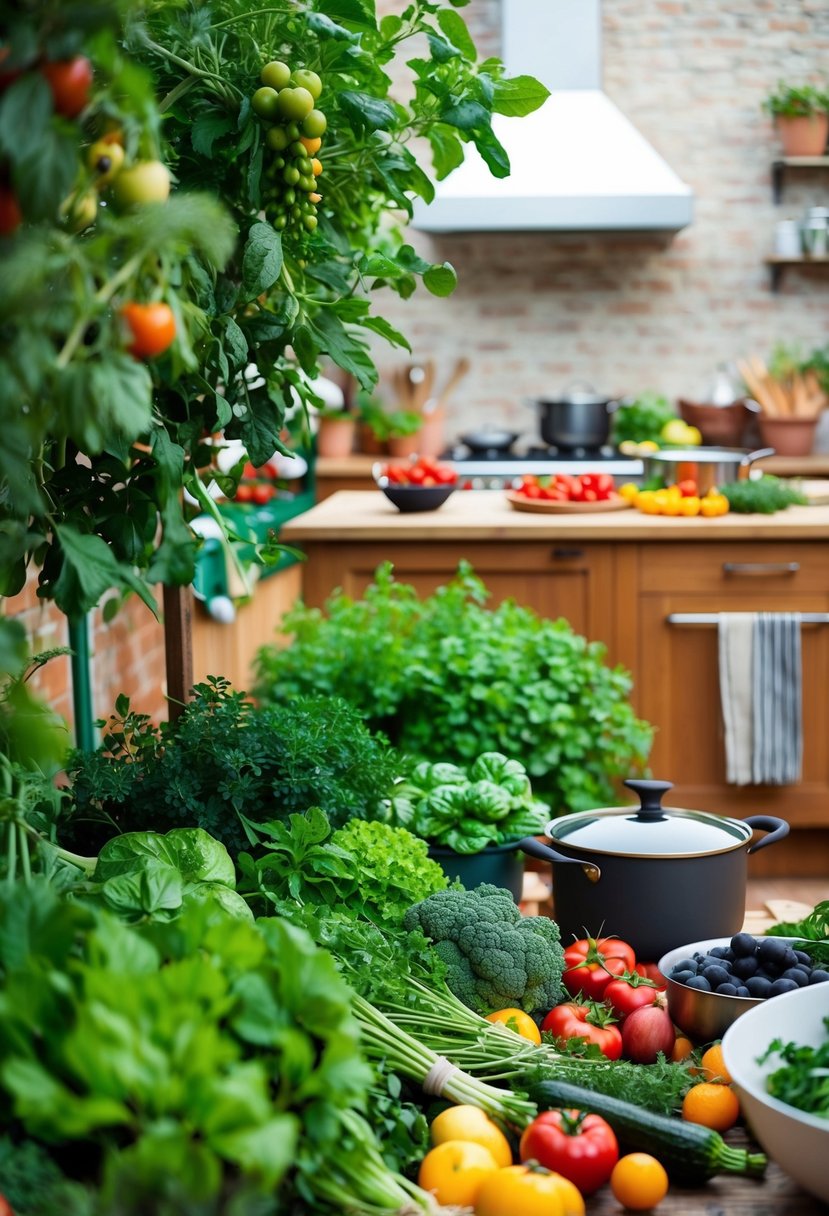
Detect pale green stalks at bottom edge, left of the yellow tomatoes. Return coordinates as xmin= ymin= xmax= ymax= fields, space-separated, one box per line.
xmin=303 ymin=1110 xmax=449 ymax=1216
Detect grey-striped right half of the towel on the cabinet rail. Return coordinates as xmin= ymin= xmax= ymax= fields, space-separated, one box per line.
xmin=751 ymin=612 xmax=803 ymax=786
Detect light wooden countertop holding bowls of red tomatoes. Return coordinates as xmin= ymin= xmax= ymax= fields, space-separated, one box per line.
xmin=280 ymin=490 xmax=829 ymax=545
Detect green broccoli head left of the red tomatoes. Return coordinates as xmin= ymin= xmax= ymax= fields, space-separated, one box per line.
xmin=405 ymin=883 xmax=564 ymax=1013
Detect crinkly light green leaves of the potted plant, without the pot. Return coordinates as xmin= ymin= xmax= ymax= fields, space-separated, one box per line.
xmin=390 ymin=751 xmax=549 ymax=854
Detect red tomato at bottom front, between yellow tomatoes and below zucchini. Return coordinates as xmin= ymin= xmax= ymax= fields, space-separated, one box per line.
xmin=519 ymin=1110 xmax=619 ymax=1195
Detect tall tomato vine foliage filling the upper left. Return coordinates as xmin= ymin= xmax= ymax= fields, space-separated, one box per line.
xmin=0 ymin=0 xmax=547 ymax=614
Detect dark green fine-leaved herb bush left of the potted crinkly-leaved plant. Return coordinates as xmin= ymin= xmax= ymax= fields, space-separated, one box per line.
xmin=68 ymin=676 xmax=399 ymax=854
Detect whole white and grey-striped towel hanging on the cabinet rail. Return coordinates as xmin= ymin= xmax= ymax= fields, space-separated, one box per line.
xmin=718 ymin=613 xmax=803 ymax=786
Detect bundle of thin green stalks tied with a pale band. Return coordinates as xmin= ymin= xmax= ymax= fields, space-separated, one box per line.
xmin=353 ymin=995 xmax=537 ymax=1127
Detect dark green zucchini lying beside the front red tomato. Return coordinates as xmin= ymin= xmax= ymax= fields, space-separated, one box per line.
xmin=530 ymin=1081 xmax=767 ymax=1187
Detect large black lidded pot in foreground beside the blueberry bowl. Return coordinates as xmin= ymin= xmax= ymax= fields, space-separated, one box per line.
xmin=519 ymin=781 xmax=789 ymax=962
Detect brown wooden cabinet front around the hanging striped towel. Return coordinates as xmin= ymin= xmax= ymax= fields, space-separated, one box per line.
xmin=636 ymin=545 xmax=829 ymax=874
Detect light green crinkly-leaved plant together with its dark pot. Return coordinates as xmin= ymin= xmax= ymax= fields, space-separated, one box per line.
xmin=390 ymin=751 xmax=551 ymax=902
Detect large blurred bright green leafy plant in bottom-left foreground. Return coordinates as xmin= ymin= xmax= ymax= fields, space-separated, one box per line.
xmin=0 ymin=884 xmax=371 ymax=1216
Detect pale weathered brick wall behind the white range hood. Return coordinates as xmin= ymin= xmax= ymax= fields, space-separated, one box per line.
xmin=377 ymin=0 xmax=829 ymax=449
